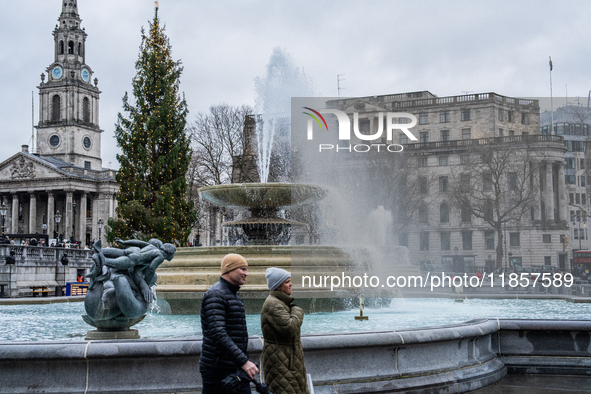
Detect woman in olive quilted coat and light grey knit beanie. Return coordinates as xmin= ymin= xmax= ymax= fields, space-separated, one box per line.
xmin=261 ymin=267 xmax=309 ymax=394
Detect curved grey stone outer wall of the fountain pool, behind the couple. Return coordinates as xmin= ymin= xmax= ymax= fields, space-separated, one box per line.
xmin=0 ymin=319 xmax=591 ymax=394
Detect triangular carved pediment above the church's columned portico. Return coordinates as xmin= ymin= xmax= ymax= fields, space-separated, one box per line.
xmin=0 ymin=153 xmax=67 ymax=182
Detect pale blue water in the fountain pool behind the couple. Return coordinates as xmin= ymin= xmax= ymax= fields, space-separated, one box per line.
xmin=0 ymin=298 xmax=591 ymax=342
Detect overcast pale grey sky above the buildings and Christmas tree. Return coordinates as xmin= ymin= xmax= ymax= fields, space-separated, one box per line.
xmin=0 ymin=0 xmax=591 ymax=168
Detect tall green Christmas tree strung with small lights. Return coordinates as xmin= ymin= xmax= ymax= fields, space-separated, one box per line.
xmin=106 ymin=8 xmax=196 ymax=245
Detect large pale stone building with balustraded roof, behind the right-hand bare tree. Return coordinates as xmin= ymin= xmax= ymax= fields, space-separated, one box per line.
xmin=327 ymin=91 xmax=570 ymax=272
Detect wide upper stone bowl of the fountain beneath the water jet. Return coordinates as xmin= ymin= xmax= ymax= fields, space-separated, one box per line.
xmin=199 ymin=183 xmax=326 ymax=210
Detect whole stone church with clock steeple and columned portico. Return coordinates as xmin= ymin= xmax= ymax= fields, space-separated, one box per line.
xmin=0 ymin=0 xmax=119 ymax=245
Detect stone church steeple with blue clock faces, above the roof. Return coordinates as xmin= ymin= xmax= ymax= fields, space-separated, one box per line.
xmin=36 ymin=0 xmax=103 ymax=170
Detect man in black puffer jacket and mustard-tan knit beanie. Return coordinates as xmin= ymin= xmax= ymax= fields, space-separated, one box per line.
xmin=199 ymin=254 xmax=258 ymax=394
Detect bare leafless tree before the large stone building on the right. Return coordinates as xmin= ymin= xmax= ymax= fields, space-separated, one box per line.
xmin=450 ymin=137 xmax=551 ymax=268
